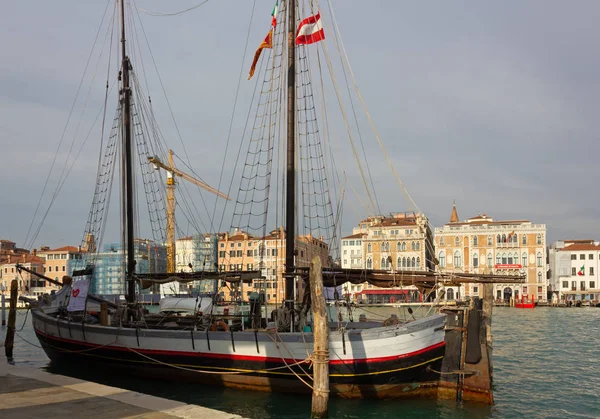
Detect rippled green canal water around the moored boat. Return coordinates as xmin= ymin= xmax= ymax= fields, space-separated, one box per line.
xmin=0 ymin=307 xmax=600 ymax=419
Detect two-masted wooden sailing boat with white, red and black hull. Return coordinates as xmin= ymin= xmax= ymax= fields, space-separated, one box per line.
xmin=23 ymin=0 xmax=508 ymax=399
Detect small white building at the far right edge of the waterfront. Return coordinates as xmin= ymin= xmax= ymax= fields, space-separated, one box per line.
xmin=548 ymin=240 xmax=600 ymax=301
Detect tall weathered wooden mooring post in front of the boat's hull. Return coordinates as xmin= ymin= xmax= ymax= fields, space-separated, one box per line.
xmin=309 ymin=256 xmax=329 ymax=418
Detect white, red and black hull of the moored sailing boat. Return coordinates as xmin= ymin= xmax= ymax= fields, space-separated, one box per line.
xmin=33 ymin=309 xmax=445 ymax=399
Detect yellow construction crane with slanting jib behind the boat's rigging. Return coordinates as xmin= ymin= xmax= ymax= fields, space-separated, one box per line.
xmin=148 ymin=150 xmax=229 ymax=272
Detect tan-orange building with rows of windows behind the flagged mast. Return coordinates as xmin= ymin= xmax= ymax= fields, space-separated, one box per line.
xmin=217 ymin=227 xmax=331 ymax=303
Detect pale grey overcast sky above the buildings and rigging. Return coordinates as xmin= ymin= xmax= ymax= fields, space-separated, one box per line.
xmin=0 ymin=0 xmax=600 ymax=247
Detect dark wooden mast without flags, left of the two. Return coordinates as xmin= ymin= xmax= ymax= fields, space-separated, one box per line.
xmin=121 ymin=0 xmax=135 ymax=303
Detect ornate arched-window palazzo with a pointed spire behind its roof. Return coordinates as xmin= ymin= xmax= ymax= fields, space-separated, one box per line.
xmin=435 ymin=205 xmax=548 ymax=301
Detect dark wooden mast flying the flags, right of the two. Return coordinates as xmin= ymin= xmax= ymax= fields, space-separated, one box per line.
xmin=285 ymin=0 xmax=296 ymax=308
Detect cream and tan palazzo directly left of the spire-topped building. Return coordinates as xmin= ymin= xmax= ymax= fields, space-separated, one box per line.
xmin=341 ymin=212 xmax=434 ymax=303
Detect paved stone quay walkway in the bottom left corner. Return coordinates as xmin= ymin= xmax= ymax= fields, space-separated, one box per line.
xmin=0 ymin=366 xmax=241 ymax=419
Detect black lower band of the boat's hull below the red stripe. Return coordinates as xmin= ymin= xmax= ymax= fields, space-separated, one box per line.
xmin=36 ymin=332 xmax=445 ymax=398
